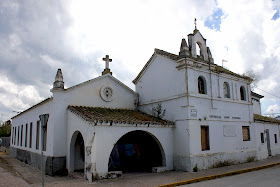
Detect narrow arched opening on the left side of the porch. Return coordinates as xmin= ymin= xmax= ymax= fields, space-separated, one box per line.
xmin=70 ymin=131 xmax=85 ymax=172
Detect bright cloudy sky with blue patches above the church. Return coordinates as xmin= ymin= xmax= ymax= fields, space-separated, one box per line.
xmin=0 ymin=0 xmax=280 ymax=120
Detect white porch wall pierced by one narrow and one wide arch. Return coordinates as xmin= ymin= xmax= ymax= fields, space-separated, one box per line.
xmin=67 ymin=111 xmax=173 ymax=178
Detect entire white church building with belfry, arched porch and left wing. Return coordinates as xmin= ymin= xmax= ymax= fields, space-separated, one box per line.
xmin=10 ymin=29 xmax=280 ymax=181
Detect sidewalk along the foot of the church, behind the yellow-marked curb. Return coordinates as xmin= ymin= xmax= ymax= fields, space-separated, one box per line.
xmin=0 ymin=152 xmax=280 ymax=187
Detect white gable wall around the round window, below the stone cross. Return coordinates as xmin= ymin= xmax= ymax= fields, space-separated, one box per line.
xmin=54 ymin=74 xmax=138 ymax=156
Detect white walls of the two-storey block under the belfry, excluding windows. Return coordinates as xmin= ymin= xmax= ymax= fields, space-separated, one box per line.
xmin=136 ymin=55 xmax=256 ymax=170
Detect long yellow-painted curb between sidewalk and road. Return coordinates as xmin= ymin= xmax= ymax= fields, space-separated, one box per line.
xmin=158 ymin=162 xmax=280 ymax=187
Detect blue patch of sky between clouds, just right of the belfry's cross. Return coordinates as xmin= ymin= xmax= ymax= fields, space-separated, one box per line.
xmin=204 ymin=8 xmax=224 ymax=31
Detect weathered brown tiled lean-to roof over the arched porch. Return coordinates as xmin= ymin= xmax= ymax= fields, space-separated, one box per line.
xmin=68 ymin=106 xmax=174 ymax=126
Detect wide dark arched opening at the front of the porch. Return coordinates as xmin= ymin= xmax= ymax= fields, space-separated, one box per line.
xmin=108 ymin=130 xmax=165 ymax=172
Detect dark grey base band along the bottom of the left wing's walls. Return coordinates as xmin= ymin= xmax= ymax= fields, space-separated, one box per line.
xmin=10 ymin=147 xmax=68 ymax=176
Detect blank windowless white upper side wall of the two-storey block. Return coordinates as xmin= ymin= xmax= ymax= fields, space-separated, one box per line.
xmin=136 ymin=55 xmax=186 ymax=103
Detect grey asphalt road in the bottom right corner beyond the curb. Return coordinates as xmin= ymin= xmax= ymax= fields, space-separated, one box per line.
xmin=183 ymin=166 xmax=280 ymax=187
